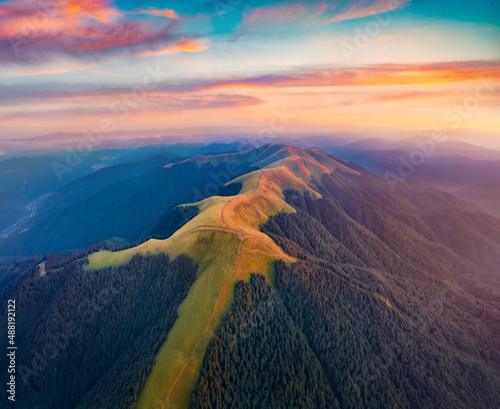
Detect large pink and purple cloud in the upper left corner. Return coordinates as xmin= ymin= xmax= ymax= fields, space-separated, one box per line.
xmin=0 ymin=0 xmax=204 ymax=65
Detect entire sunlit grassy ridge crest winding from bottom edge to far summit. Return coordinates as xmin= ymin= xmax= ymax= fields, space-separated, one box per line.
xmin=88 ymin=145 xmax=360 ymax=409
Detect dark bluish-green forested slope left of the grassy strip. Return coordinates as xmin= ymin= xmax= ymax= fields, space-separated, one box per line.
xmin=0 ymin=254 xmax=196 ymax=409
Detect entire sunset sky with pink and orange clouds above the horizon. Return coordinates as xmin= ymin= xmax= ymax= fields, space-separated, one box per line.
xmin=0 ymin=0 xmax=500 ymax=147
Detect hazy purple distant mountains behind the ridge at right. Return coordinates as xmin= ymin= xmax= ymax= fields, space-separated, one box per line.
xmin=328 ymin=136 xmax=500 ymax=217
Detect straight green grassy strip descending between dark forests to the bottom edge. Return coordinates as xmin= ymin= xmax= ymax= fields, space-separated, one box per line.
xmin=138 ymin=232 xmax=239 ymax=409
